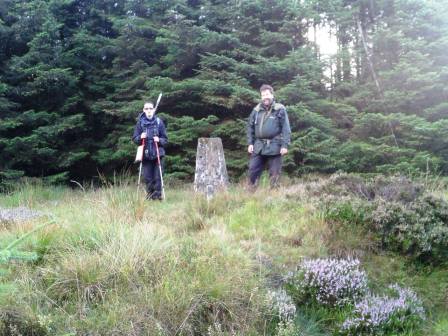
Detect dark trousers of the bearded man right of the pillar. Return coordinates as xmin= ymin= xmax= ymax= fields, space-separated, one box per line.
xmin=249 ymin=154 xmax=282 ymax=188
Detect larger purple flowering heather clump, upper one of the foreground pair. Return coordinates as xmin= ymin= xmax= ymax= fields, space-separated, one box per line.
xmin=293 ymin=258 xmax=367 ymax=306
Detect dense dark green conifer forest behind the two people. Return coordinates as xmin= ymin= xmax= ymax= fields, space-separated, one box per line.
xmin=0 ymin=0 xmax=448 ymax=185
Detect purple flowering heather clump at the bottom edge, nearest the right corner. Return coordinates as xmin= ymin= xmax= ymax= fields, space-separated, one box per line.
xmin=341 ymin=285 xmax=425 ymax=335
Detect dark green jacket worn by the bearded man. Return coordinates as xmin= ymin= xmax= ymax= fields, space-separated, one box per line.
xmin=247 ymin=102 xmax=291 ymax=155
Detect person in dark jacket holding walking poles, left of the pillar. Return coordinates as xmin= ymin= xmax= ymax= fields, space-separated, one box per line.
xmin=132 ymin=102 xmax=168 ymax=200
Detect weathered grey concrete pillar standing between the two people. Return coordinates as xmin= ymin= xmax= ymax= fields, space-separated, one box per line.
xmin=194 ymin=138 xmax=229 ymax=199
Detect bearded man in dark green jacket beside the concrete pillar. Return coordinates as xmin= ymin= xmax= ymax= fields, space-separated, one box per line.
xmin=247 ymin=84 xmax=291 ymax=189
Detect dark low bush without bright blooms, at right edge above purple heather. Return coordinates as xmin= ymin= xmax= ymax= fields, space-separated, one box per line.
xmin=320 ymin=175 xmax=448 ymax=263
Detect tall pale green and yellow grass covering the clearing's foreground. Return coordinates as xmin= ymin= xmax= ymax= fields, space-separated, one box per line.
xmin=0 ymin=180 xmax=448 ymax=335
